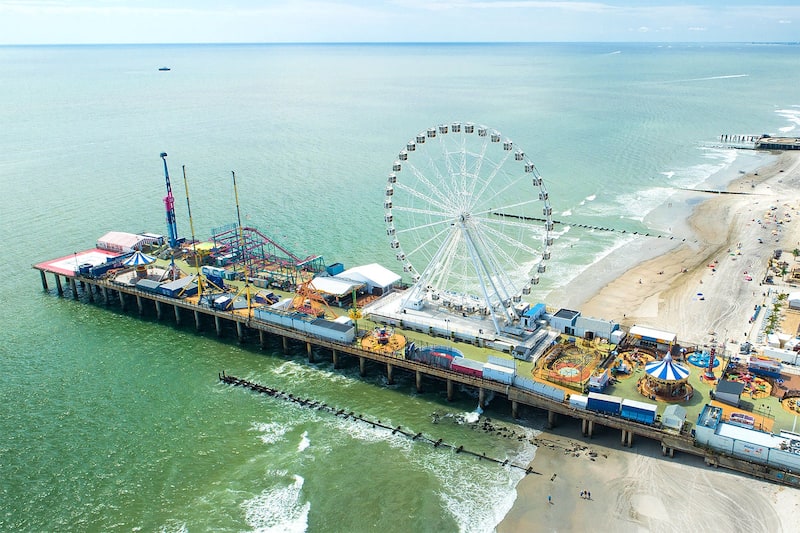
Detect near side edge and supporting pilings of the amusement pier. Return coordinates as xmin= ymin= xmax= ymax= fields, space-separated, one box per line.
xmin=34 ymin=265 xmax=800 ymax=486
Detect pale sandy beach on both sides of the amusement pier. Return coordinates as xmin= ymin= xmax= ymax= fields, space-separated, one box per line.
xmin=497 ymin=152 xmax=800 ymax=532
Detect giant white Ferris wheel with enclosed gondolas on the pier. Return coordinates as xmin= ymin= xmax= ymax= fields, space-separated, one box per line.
xmin=384 ymin=122 xmax=553 ymax=333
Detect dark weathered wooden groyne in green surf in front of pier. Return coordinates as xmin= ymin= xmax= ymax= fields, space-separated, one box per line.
xmin=219 ymin=371 xmax=541 ymax=475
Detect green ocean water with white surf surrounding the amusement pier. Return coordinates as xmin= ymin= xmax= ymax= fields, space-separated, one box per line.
xmin=0 ymin=43 xmax=800 ymax=532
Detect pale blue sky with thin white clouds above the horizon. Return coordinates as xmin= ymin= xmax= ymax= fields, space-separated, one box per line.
xmin=0 ymin=0 xmax=800 ymax=44
